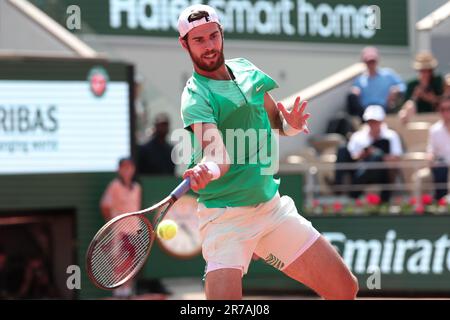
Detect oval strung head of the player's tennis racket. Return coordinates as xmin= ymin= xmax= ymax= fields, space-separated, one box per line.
xmin=90 ymin=215 xmax=153 ymax=288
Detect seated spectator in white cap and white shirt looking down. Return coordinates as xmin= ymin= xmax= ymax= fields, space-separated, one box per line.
xmin=334 ymin=105 xmax=403 ymax=202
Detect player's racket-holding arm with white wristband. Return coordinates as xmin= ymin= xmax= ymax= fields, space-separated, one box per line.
xmin=183 ymin=123 xmax=230 ymax=191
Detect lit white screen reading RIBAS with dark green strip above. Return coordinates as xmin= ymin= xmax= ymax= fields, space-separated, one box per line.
xmin=0 ymin=58 xmax=131 ymax=175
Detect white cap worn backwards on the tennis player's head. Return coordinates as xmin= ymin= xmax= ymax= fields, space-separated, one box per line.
xmin=178 ymin=4 xmax=221 ymax=37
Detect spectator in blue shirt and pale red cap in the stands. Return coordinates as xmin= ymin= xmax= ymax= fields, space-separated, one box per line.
xmin=347 ymin=47 xmax=406 ymax=118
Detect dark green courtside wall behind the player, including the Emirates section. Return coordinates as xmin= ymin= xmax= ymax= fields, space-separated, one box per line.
xmin=0 ymin=173 xmax=450 ymax=299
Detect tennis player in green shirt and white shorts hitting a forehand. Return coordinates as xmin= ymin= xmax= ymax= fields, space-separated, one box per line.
xmin=178 ymin=5 xmax=358 ymax=300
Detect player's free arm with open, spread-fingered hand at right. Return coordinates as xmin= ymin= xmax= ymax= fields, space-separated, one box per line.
xmin=264 ymin=92 xmax=311 ymax=136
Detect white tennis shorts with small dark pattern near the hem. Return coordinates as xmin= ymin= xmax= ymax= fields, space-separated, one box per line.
xmin=197 ymin=192 xmax=320 ymax=275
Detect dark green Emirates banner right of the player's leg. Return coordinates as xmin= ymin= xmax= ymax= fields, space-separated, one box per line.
xmin=311 ymin=215 xmax=450 ymax=294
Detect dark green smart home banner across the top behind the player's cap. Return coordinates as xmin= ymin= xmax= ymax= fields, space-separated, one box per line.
xmin=31 ymin=0 xmax=408 ymax=46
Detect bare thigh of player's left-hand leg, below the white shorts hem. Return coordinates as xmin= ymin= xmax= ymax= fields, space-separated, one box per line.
xmin=205 ymin=268 xmax=242 ymax=300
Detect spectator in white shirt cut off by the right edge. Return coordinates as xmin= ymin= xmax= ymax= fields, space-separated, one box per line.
xmin=427 ymin=95 xmax=450 ymax=200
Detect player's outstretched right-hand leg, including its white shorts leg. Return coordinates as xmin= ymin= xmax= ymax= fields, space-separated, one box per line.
xmin=255 ymin=196 xmax=358 ymax=299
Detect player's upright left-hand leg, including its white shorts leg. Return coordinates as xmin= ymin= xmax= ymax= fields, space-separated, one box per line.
xmin=198 ymin=205 xmax=263 ymax=300
